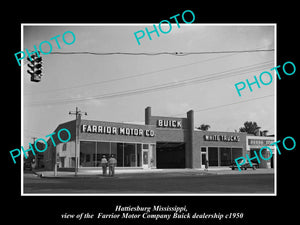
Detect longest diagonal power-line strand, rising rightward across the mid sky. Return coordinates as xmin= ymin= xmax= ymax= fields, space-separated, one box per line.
xmin=28 ymin=61 xmax=273 ymax=106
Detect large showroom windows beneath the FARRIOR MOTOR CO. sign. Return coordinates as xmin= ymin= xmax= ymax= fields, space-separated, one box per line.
xmin=80 ymin=141 xmax=148 ymax=167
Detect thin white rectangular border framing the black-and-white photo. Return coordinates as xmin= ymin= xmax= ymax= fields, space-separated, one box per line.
xmin=20 ymin=23 xmax=277 ymax=196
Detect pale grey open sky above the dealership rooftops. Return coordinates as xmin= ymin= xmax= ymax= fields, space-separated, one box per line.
xmin=21 ymin=23 xmax=276 ymax=145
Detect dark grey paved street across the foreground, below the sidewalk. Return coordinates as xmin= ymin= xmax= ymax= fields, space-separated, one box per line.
xmin=24 ymin=170 xmax=274 ymax=194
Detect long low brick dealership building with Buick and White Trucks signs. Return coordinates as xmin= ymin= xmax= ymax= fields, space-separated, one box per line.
xmin=43 ymin=107 xmax=274 ymax=170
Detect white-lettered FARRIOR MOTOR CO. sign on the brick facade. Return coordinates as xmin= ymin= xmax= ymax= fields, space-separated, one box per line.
xmin=81 ymin=124 xmax=155 ymax=137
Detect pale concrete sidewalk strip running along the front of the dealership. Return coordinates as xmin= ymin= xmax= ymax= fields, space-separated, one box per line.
xmin=33 ymin=167 xmax=274 ymax=178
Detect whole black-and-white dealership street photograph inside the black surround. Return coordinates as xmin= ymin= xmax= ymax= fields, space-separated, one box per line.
xmin=19 ymin=23 xmax=274 ymax=195
